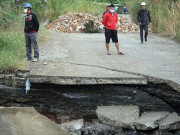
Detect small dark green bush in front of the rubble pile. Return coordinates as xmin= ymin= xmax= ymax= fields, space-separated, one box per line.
xmin=83 ymin=20 xmax=101 ymax=33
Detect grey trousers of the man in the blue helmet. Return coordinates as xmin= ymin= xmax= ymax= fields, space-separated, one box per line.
xmin=25 ymin=32 xmax=39 ymax=60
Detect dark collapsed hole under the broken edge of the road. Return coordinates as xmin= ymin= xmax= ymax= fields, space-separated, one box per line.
xmin=0 ymin=84 xmax=179 ymax=134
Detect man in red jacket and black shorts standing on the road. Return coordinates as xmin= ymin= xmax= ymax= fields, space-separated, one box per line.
xmin=102 ymin=4 xmax=124 ymax=55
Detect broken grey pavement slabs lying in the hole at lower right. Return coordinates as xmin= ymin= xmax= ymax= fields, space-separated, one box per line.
xmin=96 ymin=106 xmax=180 ymax=131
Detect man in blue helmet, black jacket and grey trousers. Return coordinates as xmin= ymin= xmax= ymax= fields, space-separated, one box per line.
xmin=24 ymin=3 xmax=39 ymax=62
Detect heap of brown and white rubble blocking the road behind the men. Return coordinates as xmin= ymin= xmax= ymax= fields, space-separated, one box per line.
xmin=47 ymin=13 xmax=139 ymax=33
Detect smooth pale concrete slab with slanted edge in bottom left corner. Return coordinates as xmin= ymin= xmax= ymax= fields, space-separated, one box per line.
xmin=0 ymin=107 xmax=72 ymax=135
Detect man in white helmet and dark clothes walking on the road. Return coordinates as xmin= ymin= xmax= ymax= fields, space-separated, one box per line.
xmin=137 ymin=2 xmax=152 ymax=44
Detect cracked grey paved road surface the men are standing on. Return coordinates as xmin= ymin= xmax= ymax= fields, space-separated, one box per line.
xmin=30 ymin=32 xmax=180 ymax=84
